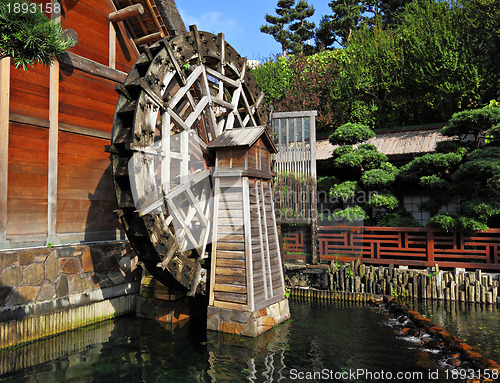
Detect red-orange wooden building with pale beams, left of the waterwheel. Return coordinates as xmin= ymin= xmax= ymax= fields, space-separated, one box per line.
xmin=0 ymin=0 xmax=185 ymax=248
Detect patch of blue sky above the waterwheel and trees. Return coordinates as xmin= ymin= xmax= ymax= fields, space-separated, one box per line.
xmin=176 ymin=0 xmax=331 ymax=60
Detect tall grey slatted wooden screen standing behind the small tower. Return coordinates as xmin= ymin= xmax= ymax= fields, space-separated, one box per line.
xmin=271 ymin=111 xmax=317 ymax=262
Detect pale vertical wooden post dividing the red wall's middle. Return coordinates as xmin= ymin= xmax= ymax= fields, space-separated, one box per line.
xmin=47 ymin=0 xmax=61 ymax=242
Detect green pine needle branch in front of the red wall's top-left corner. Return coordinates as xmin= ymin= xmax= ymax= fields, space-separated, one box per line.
xmin=0 ymin=0 xmax=73 ymax=70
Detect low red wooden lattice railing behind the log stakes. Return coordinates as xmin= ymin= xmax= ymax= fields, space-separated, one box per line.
xmin=283 ymin=226 xmax=500 ymax=270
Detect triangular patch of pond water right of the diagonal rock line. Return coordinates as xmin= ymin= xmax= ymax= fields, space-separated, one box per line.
xmin=408 ymin=300 xmax=500 ymax=362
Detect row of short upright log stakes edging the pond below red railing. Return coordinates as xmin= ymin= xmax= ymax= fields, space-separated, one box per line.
xmin=285 ymin=260 xmax=500 ymax=304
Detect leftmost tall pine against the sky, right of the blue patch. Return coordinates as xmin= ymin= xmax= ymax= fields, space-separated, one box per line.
xmin=260 ymin=0 xmax=316 ymax=56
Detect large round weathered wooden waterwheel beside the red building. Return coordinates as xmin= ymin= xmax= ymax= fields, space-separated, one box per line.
xmin=108 ymin=26 xmax=267 ymax=294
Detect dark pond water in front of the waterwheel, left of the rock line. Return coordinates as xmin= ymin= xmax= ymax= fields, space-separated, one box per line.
xmin=0 ymin=302 xmax=458 ymax=383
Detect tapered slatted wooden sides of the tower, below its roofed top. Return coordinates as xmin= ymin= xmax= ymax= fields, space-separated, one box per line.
xmin=210 ymin=177 xmax=285 ymax=311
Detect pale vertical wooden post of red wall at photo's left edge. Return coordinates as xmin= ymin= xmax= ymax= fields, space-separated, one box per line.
xmin=0 ymin=57 xmax=10 ymax=243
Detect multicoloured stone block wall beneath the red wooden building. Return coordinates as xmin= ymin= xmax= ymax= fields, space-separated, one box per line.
xmin=0 ymin=241 xmax=141 ymax=348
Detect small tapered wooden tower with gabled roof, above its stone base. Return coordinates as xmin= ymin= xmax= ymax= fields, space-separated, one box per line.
xmin=209 ymin=127 xmax=285 ymax=318
